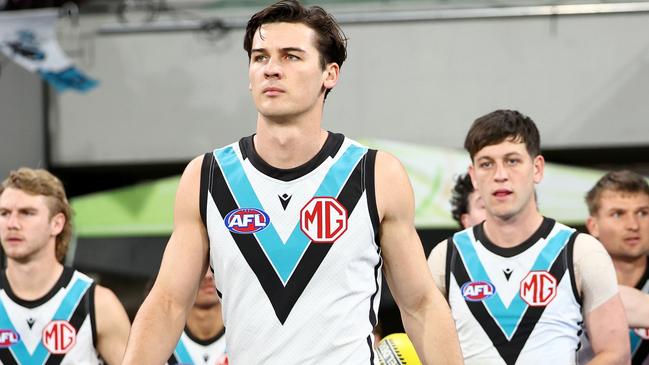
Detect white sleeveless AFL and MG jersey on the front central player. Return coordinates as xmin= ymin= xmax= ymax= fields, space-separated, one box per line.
xmin=200 ymin=133 xmax=382 ymax=365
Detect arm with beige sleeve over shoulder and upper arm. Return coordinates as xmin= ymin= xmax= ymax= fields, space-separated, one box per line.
xmin=574 ymin=234 xmax=631 ymax=365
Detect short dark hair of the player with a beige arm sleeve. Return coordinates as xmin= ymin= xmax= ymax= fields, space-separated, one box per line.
xmin=464 ymin=109 xmax=541 ymax=160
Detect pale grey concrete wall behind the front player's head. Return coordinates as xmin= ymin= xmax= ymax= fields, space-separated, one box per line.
xmin=45 ymin=8 xmax=649 ymax=165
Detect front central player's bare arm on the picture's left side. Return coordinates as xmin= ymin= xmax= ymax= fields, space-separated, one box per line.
xmin=118 ymin=156 xmax=208 ymax=365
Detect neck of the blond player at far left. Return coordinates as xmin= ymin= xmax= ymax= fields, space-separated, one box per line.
xmin=6 ymin=257 xmax=63 ymax=300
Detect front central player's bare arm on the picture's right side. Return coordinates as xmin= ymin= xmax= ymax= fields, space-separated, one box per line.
xmin=375 ymin=152 xmax=462 ymax=365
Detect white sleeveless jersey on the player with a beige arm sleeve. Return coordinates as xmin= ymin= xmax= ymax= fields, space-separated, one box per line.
xmin=446 ymin=218 xmax=582 ymax=365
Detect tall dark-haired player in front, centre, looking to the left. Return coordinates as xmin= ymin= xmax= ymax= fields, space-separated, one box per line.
xmin=125 ymin=1 xmax=461 ymax=365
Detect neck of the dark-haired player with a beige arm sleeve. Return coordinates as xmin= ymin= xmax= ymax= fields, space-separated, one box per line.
xmin=484 ymin=204 xmax=543 ymax=248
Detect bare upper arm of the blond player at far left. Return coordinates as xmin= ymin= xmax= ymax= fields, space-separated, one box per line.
xmin=95 ymin=285 xmax=131 ymax=365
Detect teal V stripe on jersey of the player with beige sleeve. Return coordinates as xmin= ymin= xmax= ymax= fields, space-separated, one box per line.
xmin=453 ymin=229 xmax=572 ymax=340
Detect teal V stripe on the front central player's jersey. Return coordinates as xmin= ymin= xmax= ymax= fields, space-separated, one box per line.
xmin=214 ymin=145 xmax=367 ymax=285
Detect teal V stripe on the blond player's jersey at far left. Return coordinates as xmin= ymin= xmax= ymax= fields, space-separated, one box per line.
xmin=0 ymin=278 xmax=92 ymax=365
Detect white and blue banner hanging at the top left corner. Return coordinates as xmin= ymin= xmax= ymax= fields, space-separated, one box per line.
xmin=0 ymin=9 xmax=98 ymax=92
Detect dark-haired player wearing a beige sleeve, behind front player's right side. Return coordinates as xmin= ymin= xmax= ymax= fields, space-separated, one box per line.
xmin=429 ymin=110 xmax=629 ymax=365
